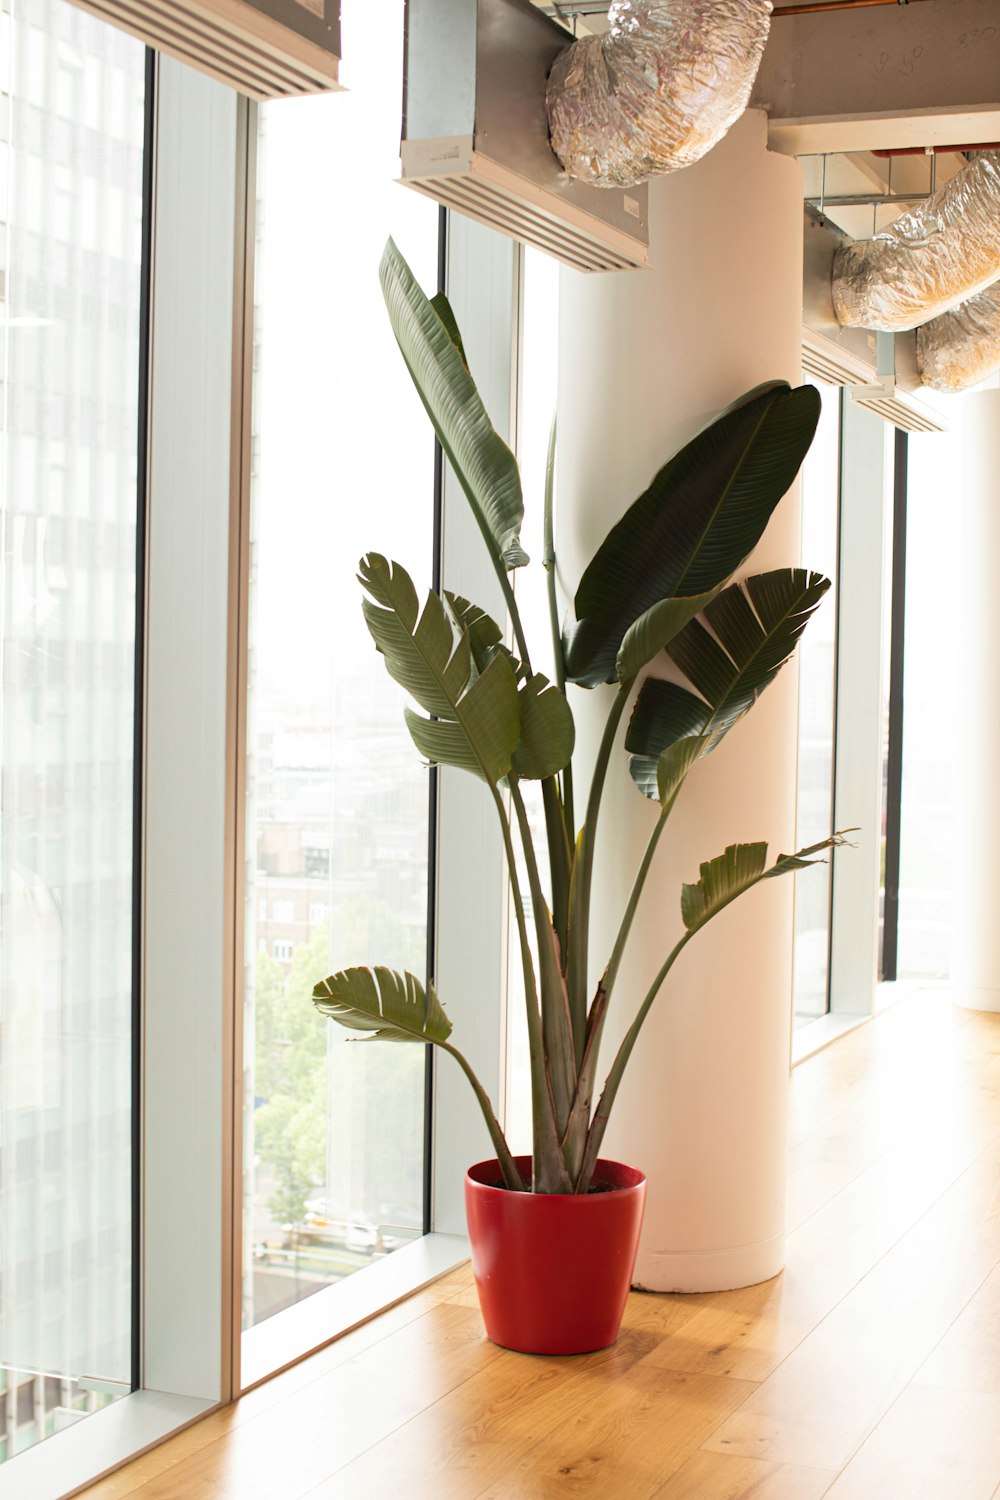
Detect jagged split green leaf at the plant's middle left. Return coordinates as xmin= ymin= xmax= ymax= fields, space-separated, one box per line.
xmin=358 ymin=552 xmax=520 ymax=785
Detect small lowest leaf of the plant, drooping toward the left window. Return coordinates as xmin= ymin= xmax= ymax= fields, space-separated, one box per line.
xmin=312 ymin=968 xmax=451 ymax=1043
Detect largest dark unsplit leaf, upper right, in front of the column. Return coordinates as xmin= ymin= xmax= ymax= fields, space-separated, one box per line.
xmin=565 ymin=381 xmax=820 ymax=687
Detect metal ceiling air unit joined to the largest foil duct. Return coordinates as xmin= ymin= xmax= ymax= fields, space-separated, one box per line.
xmin=402 ymin=0 xmax=649 ymax=272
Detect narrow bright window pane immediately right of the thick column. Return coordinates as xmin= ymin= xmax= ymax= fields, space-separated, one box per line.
xmin=795 ymin=386 xmax=843 ymax=1025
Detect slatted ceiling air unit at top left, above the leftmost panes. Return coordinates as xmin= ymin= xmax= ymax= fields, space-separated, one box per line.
xmin=72 ymin=0 xmax=340 ymax=99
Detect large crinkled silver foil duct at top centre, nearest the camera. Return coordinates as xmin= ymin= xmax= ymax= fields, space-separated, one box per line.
xmin=547 ymin=0 xmax=772 ymax=188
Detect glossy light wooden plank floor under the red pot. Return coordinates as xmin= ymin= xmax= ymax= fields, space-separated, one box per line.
xmin=87 ymin=992 xmax=1000 ymax=1500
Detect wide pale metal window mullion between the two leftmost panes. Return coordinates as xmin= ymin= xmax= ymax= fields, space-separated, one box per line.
xmin=142 ymin=59 xmax=241 ymax=1401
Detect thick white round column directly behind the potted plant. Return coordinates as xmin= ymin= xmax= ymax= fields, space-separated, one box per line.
xmin=558 ymin=113 xmax=808 ymax=1292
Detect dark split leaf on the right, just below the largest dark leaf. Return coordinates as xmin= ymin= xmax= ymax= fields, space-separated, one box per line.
xmin=625 ymin=569 xmax=829 ymax=798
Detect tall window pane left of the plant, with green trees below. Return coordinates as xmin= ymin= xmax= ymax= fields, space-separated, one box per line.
xmin=243 ymin=0 xmax=438 ymax=1328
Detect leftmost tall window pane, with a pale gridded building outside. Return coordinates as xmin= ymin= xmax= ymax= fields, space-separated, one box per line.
xmin=0 ymin=0 xmax=144 ymax=1458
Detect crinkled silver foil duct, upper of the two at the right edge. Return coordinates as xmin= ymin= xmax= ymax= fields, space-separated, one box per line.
xmin=832 ymin=152 xmax=1000 ymax=333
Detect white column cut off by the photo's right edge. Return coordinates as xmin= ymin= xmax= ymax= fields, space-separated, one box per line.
xmin=952 ymin=390 xmax=1000 ymax=1011
